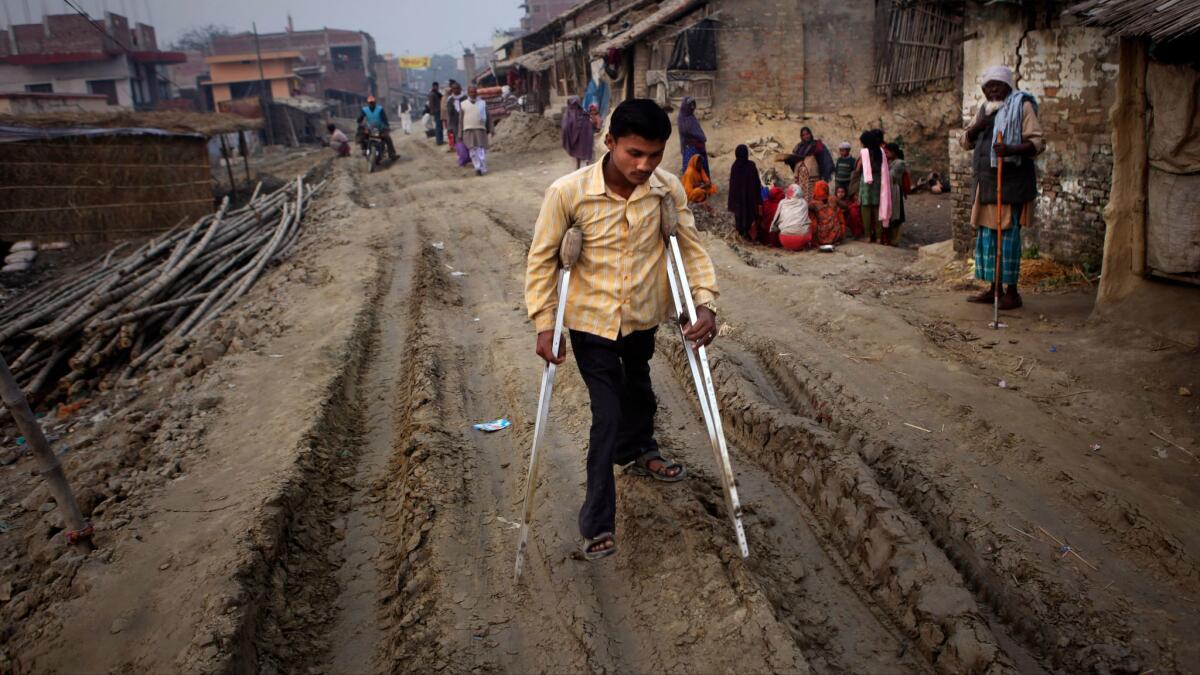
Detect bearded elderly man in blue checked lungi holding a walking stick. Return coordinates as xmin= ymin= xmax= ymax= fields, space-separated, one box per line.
xmin=959 ymin=66 xmax=1045 ymax=310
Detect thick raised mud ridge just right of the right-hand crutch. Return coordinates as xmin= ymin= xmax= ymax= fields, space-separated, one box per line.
xmin=666 ymin=345 xmax=1013 ymax=673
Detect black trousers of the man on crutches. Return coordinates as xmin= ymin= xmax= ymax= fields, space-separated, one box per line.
xmin=571 ymin=328 xmax=659 ymax=537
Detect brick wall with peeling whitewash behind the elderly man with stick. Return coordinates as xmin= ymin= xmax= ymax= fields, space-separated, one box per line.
xmin=949 ymin=4 xmax=1117 ymax=265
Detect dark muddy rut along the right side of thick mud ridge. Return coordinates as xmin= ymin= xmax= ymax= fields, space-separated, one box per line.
xmin=691 ymin=324 xmax=1170 ymax=670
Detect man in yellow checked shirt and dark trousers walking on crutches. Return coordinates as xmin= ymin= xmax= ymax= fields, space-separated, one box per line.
xmin=526 ymin=98 xmax=718 ymax=560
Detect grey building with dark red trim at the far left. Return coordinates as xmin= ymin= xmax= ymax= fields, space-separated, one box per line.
xmin=0 ymin=12 xmax=186 ymax=109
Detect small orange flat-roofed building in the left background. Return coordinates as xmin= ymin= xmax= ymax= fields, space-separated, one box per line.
xmin=204 ymin=52 xmax=302 ymax=112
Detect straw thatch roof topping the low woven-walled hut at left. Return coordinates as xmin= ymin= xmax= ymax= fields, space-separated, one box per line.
xmin=0 ymin=110 xmax=263 ymax=136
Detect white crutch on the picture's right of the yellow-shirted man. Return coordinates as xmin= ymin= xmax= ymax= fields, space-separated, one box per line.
xmin=660 ymin=195 xmax=750 ymax=557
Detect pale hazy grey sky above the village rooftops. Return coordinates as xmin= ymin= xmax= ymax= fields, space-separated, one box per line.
xmin=0 ymin=0 xmax=522 ymax=55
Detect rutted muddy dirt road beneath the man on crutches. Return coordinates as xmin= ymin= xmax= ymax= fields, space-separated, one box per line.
xmin=7 ymin=132 xmax=1200 ymax=674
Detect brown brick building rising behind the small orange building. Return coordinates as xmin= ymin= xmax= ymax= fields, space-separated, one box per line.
xmin=211 ymin=28 xmax=382 ymax=103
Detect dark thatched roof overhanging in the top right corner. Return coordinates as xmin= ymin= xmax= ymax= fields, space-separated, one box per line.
xmin=1068 ymin=0 xmax=1200 ymax=42
